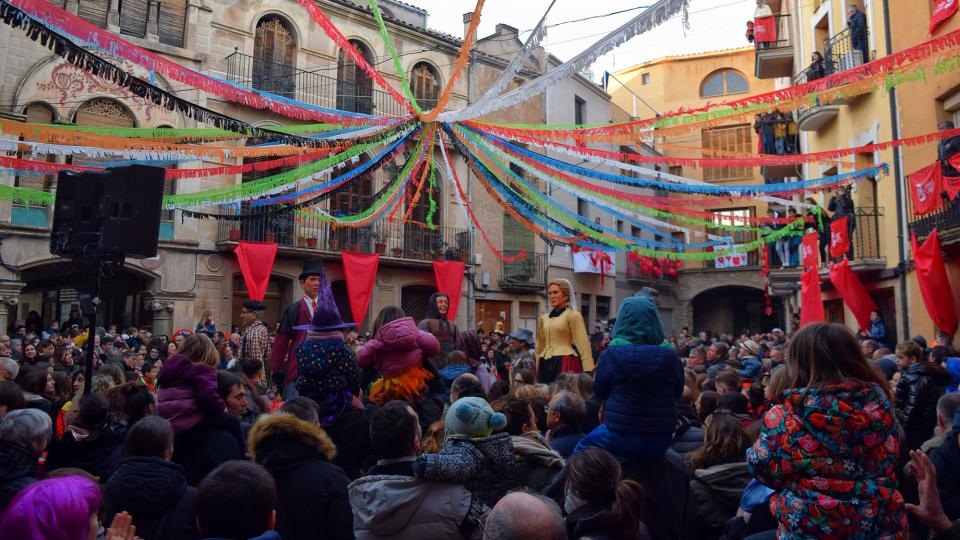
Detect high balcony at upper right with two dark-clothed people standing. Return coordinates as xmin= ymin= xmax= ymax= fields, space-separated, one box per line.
xmin=793 ymin=28 xmax=872 ymax=131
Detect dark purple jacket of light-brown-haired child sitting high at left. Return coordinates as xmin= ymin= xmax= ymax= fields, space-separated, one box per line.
xmin=157 ymin=354 xmax=226 ymax=433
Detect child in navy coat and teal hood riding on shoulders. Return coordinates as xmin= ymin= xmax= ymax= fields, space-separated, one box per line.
xmin=575 ymin=296 xmax=684 ymax=457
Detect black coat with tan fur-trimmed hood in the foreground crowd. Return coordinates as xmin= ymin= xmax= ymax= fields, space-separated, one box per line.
xmin=250 ymin=414 xmax=353 ymax=540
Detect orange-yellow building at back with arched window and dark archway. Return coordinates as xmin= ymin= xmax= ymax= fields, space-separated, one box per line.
xmin=607 ymin=47 xmax=797 ymax=333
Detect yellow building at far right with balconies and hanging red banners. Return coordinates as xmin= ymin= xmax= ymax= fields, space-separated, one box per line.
xmin=755 ymin=0 xmax=960 ymax=344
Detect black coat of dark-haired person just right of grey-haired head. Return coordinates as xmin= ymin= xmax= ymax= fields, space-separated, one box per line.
xmin=46 ymin=428 xmax=123 ymax=483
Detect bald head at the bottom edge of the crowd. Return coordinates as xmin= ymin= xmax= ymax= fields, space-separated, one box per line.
xmin=483 ymin=491 xmax=566 ymax=540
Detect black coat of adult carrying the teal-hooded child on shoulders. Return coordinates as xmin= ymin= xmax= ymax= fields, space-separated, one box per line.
xmin=621 ymin=450 xmax=690 ymax=540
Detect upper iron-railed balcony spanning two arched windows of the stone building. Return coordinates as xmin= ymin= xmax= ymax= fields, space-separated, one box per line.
xmin=227 ymin=49 xmax=406 ymax=116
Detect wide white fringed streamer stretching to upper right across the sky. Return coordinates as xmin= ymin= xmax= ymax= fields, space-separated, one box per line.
xmin=442 ymin=0 xmax=690 ymax=120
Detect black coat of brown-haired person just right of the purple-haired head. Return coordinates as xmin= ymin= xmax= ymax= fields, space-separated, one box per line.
xmin=103 ymin=457 xmax=199 ymax=540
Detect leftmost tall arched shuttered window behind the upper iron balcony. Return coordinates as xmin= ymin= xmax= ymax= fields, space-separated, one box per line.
xmin=252 ymin=15 xmax=297 ymax=97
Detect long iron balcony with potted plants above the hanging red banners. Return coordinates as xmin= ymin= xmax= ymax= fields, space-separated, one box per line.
xmin=217 ymin=208 xmax=473 ymax=263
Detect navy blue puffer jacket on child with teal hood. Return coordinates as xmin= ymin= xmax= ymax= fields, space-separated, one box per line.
xmin=593 ymin=345 xmax=683 ymax=435
